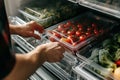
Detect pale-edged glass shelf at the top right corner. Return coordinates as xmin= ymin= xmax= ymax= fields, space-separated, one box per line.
xmin=69 ymin=0 xmax=120 ymax=19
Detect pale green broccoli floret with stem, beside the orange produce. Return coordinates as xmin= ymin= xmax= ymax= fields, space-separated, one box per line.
xmin=99 ymin=49 xmax=116 ymax=69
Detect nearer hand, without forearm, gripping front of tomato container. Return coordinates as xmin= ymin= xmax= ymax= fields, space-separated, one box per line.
xmin=34 ymin=42 xmax=65 ymax=62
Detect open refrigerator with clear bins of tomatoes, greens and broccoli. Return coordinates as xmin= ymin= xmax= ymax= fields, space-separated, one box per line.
xmin=5 ymin=0 xmax=120 ymax=80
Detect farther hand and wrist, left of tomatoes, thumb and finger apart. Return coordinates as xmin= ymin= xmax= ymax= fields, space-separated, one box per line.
xmin=10 ymin=21 xmax=44 ymax=39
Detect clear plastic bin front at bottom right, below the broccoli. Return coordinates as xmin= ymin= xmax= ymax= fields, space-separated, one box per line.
xmin=72 ymin=61 xmax=114 ymax=80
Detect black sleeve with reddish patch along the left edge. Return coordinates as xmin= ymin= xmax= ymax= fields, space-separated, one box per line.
xmin=0 ymin=0 xmax=15 ymax=80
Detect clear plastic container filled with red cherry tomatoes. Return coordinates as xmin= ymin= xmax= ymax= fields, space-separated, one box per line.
xmin=47 ymin=12 xmax=116 ymax=52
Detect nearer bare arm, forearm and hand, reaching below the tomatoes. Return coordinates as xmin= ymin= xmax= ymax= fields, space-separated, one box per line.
xmin=4 ymin=42 xmax=65 ymax=80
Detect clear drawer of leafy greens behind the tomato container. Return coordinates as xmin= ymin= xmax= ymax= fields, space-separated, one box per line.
xmin=19 ymin=0 xmax=79 ymax=28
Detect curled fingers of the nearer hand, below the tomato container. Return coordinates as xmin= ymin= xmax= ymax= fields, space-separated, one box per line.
xmin=43 ymin=42 xmax=65 ymax=62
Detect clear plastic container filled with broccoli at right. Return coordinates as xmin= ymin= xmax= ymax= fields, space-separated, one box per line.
xmin=76 ymin=32 xmax=120 ymax=80
